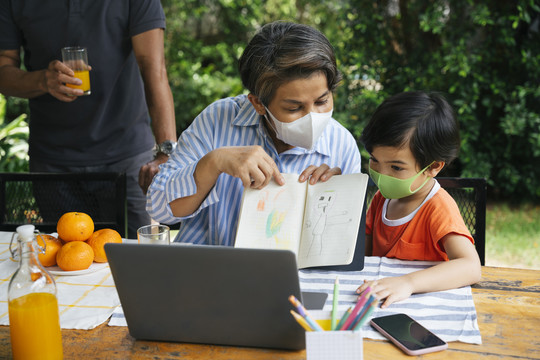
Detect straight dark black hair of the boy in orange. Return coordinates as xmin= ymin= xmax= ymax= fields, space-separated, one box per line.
xmin=360 ymin=91 xmax=460 ymax=168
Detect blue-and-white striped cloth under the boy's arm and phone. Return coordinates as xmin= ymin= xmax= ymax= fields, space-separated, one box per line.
xmin=109 ymin=257 xmax=482 ymax=344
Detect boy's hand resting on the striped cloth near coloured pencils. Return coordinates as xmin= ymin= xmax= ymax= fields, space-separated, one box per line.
xmin=356 ymin=276 xmax=413 ymax=308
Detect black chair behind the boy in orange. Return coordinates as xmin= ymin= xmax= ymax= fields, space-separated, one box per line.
xmin=366 ymin=177 xmax=487 ymax=265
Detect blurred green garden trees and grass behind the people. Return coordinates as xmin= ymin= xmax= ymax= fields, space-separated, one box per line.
xmin=0 ymin=0 xmax=540 ymax=269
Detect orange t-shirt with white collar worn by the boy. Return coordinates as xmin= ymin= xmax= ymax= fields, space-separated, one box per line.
xmin=366 ymin=184 xmax=474 ymax=261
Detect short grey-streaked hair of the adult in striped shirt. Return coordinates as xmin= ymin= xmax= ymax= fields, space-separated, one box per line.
xmin=238 ymin=21 xmax=341 ymax=105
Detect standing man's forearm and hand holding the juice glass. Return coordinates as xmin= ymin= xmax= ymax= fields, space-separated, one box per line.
xmin=0 ymin=50 xmax=83 ymax=102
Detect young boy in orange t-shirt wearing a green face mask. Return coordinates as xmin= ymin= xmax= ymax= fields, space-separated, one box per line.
xmin=357 ymin=92 xmax=481 ymax=308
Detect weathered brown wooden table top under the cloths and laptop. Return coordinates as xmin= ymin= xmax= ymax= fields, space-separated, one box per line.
xmin=0 ymin=267 xmax=540 ymax=360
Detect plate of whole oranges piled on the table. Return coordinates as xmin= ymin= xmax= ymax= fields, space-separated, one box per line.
xmin=37 ymin=212 xmax=122 ymax=275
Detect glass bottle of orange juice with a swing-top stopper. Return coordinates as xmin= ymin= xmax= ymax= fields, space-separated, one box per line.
xmin=8 ymin=225 xmax=63 ymax=360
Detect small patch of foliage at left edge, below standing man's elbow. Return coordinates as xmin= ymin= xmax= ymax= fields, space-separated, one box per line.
xmin=0 ymin=94 xmax=28 ymax=172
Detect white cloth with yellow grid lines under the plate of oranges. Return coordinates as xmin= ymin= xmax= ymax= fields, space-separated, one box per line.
xmin=0 ymin=232 xmax=120 ymax=330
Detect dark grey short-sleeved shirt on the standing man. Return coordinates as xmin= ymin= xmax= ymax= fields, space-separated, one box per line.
xmin=0 ymin=0 xmax=165 ymax=166
